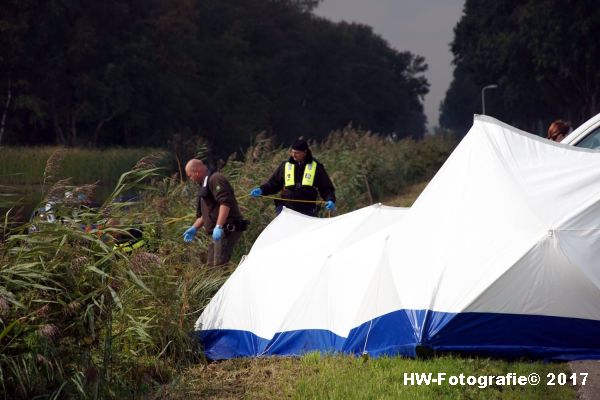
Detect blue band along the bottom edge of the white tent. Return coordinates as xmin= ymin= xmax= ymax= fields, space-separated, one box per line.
xmin=198 ymin=310 xmax=600 ymax=360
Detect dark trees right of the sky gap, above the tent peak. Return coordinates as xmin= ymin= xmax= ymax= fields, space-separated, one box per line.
xmin=440 ymin=0 xmax=600 ymax=134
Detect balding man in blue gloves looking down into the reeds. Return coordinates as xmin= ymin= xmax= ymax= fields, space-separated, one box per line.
xmin=183 ymin=159 xmax=248 ymax=266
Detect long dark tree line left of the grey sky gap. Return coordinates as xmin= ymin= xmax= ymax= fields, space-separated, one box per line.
xmin=0 ymin=0 xmax=429 ymax=154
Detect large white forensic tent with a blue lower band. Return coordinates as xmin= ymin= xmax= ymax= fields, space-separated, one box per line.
xmin=196 ymin=116 xmax=600 ymax=359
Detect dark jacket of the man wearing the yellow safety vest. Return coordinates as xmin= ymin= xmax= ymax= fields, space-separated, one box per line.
xmin=260 ymin=151 xmax=335 ymax=215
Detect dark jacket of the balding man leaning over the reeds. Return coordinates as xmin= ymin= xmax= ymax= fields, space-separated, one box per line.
xmin=196 ymin=172 xmax=242 ymax=233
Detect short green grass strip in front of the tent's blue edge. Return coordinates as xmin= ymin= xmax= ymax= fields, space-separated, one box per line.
xmin=171 ymin=353 xmax=576 ymax=399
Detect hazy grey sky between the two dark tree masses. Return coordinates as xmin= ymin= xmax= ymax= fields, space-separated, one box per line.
xmin=315 ymin=0 xmax=464 ymax=127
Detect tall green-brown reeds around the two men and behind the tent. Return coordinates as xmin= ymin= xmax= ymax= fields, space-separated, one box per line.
xmin=0 ymin=128 xmax=455 ymax=398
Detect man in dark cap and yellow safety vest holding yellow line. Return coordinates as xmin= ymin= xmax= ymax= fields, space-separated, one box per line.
xmin=250 ymin=139 xmax=335 ymax=217
